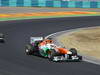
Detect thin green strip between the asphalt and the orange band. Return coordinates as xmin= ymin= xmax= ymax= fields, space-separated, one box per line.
xmin=0 ymin=14 xmax=100 ymax=21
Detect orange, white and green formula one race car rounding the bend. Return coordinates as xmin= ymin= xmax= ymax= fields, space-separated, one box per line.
xmin=25 ymin=37 xmax=82 ymax=62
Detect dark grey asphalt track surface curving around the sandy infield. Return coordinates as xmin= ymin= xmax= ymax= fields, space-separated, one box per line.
xmin=0 ymin=16 xmax=100 ymax=75
